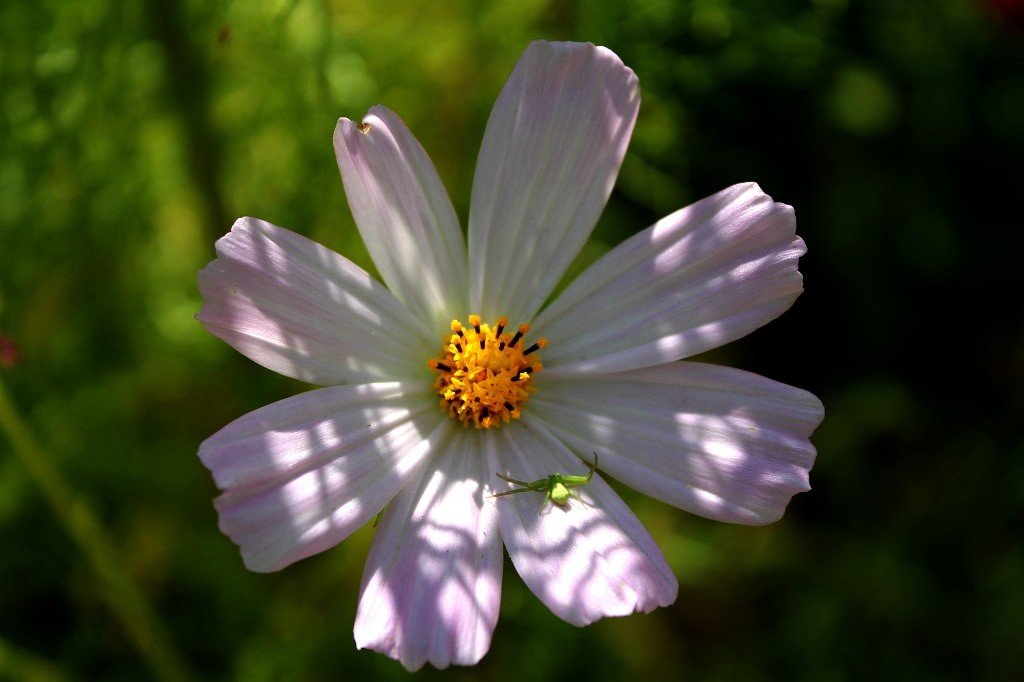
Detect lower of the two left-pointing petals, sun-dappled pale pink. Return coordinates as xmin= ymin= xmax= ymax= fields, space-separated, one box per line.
xmin=200 ymin=383 xmax=452 ymax=572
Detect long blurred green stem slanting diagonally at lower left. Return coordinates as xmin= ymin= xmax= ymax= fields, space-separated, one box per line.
xmin=0 ymin=379 xmax=191 ymax=682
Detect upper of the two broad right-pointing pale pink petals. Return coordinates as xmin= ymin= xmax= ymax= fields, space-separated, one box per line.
xmin=532 ymin=183 xmax=806 ymax=378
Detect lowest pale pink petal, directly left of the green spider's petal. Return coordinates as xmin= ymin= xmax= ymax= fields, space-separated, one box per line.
xmin=355 ymin=429 xmax=503 ymax=671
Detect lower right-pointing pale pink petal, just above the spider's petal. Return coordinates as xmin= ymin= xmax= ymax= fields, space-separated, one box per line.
xmin=529 ymin=363 xmax=823 ymax=524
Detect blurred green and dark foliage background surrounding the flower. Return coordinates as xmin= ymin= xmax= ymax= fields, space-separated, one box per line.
xmin=0 ymin=0 xmax=1024 ymax=680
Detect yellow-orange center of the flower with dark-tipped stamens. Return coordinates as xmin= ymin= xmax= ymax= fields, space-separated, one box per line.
xmin=428 ymin=315 xmax=548 ymax=429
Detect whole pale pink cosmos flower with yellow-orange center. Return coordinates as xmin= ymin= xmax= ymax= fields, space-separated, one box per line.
xmin=198 ymin=42 xmax=822 ymax=670
